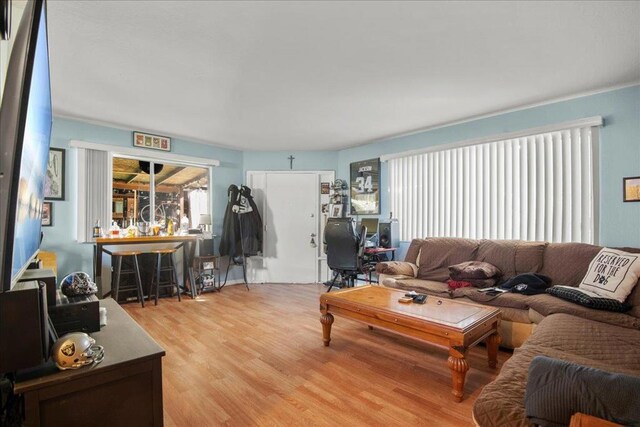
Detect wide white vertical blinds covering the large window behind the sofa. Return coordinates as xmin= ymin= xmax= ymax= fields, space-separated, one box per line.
xmin=389 ymin=126 xmax=598 ymax=243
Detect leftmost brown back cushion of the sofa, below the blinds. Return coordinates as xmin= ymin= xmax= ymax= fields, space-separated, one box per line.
xmin=418 ymin=237 xmax=478 ymax=286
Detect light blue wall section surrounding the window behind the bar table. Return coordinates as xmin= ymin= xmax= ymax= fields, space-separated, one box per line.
xmin=41 ymin=118 xmax=243 ymax=278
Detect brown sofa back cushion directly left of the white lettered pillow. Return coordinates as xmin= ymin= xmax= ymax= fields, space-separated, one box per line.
xmin=540 ymin=243 xmax=601 ymax=286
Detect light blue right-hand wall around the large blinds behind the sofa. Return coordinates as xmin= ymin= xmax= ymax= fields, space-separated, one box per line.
xmin=337 ymin=86 xmax=640 ymax=247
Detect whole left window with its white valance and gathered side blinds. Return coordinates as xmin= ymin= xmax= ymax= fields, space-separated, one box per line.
xmin=69 ymin=140 xmax=220 ymax=243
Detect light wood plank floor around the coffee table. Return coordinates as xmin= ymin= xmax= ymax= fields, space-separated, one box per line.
xmin=124 ymin=284 xmax=510 ymax=427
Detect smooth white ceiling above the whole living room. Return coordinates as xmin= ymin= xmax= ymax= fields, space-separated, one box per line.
xmin=49 ymin=0 xmax=640 ymax=150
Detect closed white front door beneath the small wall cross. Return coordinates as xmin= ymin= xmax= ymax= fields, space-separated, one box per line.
xmin=263 ymin=172 xmax=320 ymax=283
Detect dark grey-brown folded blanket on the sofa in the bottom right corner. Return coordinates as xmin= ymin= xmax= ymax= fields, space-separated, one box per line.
xmin=524 ymin=356 xmax=640 ymax=427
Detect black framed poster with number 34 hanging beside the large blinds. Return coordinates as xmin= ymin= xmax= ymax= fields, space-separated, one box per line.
xmin=350 ymin=159 xmax=380 ymax=215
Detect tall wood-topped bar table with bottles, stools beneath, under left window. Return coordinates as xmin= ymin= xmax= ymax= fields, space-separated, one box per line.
xmin=93 ymin=234 xmax=199 ymax=298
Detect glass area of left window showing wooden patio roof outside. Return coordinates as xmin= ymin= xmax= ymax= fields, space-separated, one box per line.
xmin=111 ymin=155 xmax=209 ymax=231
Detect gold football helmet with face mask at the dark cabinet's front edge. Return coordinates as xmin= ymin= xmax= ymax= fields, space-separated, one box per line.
xmin=52 ymin=332 xmax=104 ymax=370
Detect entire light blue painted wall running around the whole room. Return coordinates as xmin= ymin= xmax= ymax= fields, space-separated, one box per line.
xmin=43 ymin=86 xmax=640 ymax=277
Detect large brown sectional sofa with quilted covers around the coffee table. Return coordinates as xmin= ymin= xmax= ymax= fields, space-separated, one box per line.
xmin=377 ymin=238 xmax=640 ymax=426
